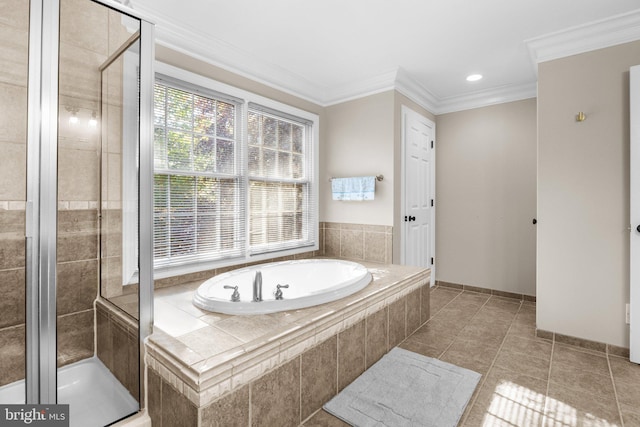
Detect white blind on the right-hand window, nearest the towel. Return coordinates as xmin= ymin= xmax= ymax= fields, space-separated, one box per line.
xmin=247 ymin=103 xmax=317 ymax=254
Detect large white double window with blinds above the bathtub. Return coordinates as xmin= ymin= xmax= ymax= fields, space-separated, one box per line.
xmin=154 ymin=64 xmax=318 ymax=277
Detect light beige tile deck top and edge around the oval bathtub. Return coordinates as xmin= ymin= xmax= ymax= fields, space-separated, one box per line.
xmin=147 ymin=262 xmax=429 ymax=407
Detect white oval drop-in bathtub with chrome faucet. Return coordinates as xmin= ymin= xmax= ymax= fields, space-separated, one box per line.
xmin=193 ymin=259 xmax=371 ymax=314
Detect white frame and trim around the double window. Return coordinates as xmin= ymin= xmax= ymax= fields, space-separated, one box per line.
xmin=154 ymin=61 xmax=320 ymax=278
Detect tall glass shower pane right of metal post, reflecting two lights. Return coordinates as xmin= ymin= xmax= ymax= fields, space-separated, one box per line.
xmin=56 ymin=0 xmax=141 ymax=426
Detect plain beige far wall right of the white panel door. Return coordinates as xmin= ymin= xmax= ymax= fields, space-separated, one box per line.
xmin=436 ymin=99 xmax=536 ymax=295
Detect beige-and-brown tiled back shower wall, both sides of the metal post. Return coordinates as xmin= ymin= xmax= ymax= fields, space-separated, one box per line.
xmin=0 ymin=0 xmax=136 ymax=386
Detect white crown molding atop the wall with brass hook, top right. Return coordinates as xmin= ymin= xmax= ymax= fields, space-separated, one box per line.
xmin=525 ymin=9 xmax=640 ymax=66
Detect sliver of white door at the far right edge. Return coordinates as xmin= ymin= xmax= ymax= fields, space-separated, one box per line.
xmin=629 ymin=65 xmax=640 ymax=363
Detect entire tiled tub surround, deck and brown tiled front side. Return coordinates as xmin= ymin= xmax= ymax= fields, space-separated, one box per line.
xmin=146 ymin=263 xmax=430 ymax=426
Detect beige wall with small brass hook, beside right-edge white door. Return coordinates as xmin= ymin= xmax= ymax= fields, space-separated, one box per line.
xmin=537 ymin=42 xmax=640 ymax=347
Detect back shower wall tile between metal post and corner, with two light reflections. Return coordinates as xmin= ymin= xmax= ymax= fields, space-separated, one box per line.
xmin=57 ymin=0 xmax=122 ymax=372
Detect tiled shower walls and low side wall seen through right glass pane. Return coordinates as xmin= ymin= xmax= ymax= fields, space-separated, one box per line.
xmin=58 ymin=0 xmax=139 ymax=374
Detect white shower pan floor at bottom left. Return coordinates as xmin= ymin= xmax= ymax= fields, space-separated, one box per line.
xmin=0 ymin=356 xmax=139 ymax=427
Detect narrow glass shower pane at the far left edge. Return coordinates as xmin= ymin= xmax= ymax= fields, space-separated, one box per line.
xmin=0 ymin=0 xmax=29 ymax=404
